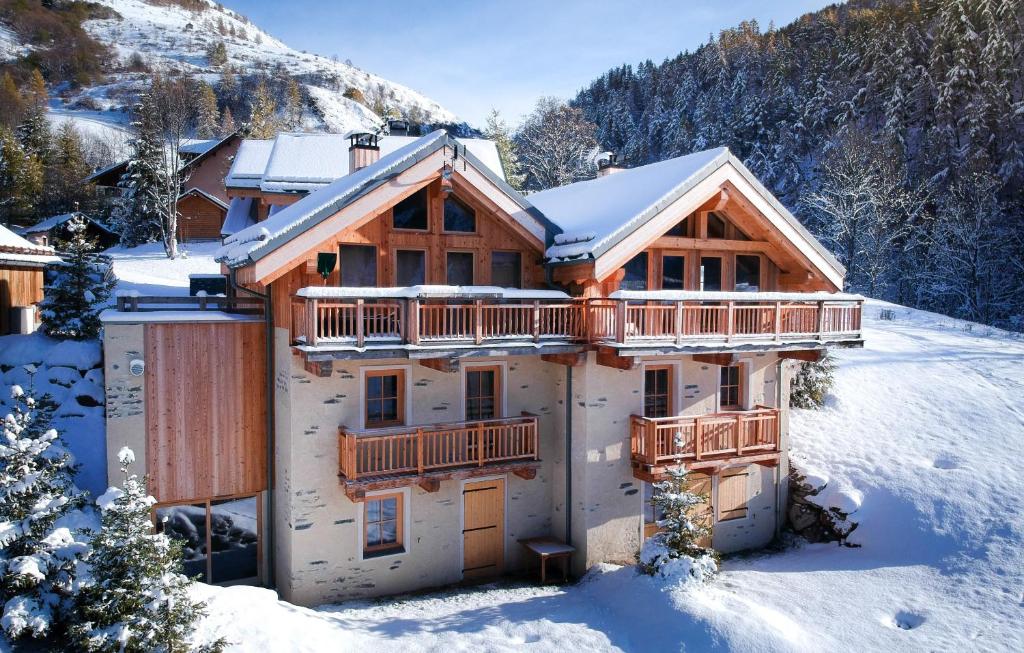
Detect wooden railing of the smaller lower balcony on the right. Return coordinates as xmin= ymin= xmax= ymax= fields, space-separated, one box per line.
xmin=630 ymin=406 xmax=779 ymax=467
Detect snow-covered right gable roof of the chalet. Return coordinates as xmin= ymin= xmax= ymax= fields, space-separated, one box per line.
xmin=529 ymin=147 xmax=846 ymax=286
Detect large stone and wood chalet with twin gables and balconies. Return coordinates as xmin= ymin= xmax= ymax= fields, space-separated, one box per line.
xmin=103 ymin=131 xmax=862 ymax=605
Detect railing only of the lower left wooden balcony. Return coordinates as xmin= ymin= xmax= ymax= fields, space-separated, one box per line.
xmin=338 ymin=417 xmax=540 ymax=480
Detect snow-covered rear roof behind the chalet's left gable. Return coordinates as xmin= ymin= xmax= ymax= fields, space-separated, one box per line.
xmin=225 ymin=132 xmax=505 ymax=192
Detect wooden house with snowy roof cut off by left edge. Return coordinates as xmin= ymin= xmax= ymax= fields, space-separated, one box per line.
xmin=0 ymin=225 xmax=60 ymax=336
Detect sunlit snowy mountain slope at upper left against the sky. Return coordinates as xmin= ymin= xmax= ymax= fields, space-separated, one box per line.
xmin=72 ymin=0 xmax=458 ymax=131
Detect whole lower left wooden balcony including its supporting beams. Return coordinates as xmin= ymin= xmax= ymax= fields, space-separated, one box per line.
xmin=338 ymin=416 xmax=540 ymax=499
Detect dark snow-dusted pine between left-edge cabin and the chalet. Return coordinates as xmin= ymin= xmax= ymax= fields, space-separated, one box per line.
xmin=40 ymin=217 xmax=114 ymax=340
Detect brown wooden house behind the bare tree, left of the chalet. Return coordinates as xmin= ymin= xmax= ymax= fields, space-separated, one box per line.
xmin=86 ymin=132 xmax=242 ymax=242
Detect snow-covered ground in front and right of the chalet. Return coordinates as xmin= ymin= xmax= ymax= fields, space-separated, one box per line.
xmin=188 ymin=302 xmax=1024 ymax=651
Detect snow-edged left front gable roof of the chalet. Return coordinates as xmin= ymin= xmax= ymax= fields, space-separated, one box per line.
xmin=215 ymin=130 xmax=557 ymax=267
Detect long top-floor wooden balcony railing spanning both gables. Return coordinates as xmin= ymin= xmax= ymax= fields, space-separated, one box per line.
xmin=292 ymin=294 xmax=863 ymax=348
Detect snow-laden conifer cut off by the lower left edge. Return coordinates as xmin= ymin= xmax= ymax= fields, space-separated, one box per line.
xmin=0 ymin=386 xmax=87 ymax=639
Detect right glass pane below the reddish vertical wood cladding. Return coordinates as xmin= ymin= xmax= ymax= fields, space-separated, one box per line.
xmin=210 ymin=496 xmax=259 ymax=582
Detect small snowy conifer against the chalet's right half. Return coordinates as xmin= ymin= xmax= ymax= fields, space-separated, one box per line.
xmin=639 ymin=469 xmax=718 ymax=583
